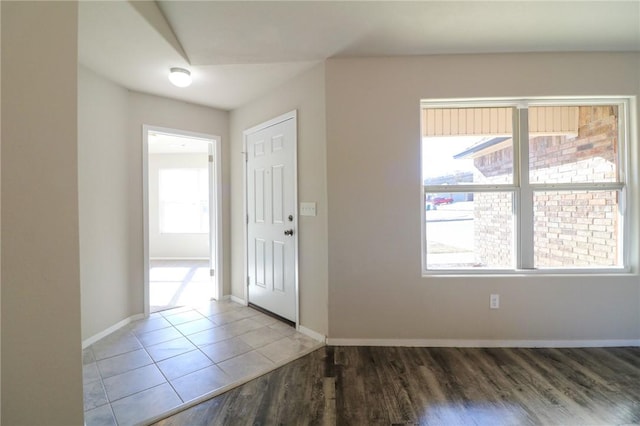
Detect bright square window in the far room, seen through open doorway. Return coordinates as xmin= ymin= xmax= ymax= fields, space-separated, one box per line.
xmin=158 ymin=168 xmax=209 ymax=234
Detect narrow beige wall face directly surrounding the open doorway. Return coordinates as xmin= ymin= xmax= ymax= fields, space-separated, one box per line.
xmin=128 ymin=92 xmax=231 ymax=306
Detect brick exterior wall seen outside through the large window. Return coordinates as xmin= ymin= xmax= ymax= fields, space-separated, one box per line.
xmin=474 ymin=106 xmax=618 ymax=267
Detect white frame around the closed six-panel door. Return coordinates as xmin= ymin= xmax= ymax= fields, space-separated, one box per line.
xmin=242 ymin=109 xmax=300 ymax=329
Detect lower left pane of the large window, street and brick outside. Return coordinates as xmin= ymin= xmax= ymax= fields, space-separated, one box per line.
xmin=425 ymin=192 xmax=514 ymax=269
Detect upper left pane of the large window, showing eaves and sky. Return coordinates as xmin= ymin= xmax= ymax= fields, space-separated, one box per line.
xmin=422 ymin=108 xmax=513 ymax=185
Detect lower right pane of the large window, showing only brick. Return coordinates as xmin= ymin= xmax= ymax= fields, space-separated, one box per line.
xmin=534 ymin=191 xmax=621 ymax=268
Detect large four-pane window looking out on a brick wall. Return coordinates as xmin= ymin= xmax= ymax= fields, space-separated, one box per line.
xmin=422 ymin=99 xmax=627 ymax=272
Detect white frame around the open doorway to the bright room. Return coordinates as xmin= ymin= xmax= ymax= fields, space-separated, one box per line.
xmin=142 ymin=124 xmax=224 ymax=317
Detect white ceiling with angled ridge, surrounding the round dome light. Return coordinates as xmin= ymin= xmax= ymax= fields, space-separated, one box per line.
xmin=79 ymin=0 xmax=640 ymax=110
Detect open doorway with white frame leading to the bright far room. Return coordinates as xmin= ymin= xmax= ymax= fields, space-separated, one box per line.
xmin=143 ymin=126 xmax=223 ymax=315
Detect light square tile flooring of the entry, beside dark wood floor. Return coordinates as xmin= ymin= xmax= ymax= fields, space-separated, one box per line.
xmin=83 ymin=301 xmax=322 ymax=426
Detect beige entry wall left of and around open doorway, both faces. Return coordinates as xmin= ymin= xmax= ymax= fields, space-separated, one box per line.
xmin=78 ymin=72 xmax=230 ymax=340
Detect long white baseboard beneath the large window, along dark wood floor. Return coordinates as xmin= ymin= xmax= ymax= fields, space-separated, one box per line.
xmin=327 ymin=338 xmax=640 ymax=348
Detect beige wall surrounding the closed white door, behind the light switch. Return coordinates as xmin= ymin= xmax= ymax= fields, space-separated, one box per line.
xmin=231 ymin=65 xmax=328 ymax=335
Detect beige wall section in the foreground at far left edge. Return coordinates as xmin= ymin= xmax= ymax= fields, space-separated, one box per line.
xmin=0 ymin=2 xmax=83 ymax=426
